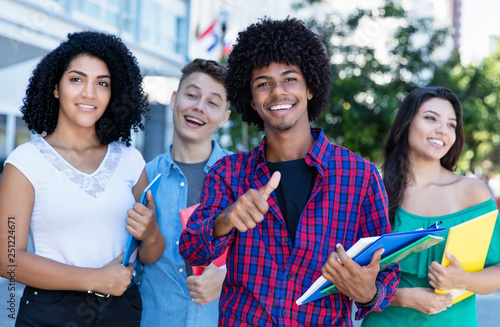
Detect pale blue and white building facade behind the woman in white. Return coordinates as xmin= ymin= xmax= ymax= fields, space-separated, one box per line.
xmin=0 ymin=0 xmax=190 ymax=164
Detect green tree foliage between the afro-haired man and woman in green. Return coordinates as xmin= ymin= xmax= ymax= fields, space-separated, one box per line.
xmin=307 ymin=1 xmax=448 ymax=163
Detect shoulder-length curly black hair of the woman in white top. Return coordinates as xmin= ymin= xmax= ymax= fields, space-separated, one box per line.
xmin=21 ymin=31 xmax=148 ymax=145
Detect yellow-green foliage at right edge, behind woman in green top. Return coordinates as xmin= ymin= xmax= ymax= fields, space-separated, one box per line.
xmin=433 ymin=47 xmax=500 ymax=174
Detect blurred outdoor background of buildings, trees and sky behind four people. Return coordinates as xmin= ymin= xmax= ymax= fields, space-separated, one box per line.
xmin=0 ymin=0 xmax=500 ymax=326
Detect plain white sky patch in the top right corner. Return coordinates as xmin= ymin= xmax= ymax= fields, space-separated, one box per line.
xmin=461 ymin=0 xmax=500 ymax=63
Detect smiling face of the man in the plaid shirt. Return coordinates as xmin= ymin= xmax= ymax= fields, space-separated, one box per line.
xmin=250 ymin=62 xmax=312 ymax=133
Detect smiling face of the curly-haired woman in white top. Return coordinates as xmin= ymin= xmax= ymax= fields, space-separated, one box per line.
xmin=54 ymin=54 xmax=111 ymax=128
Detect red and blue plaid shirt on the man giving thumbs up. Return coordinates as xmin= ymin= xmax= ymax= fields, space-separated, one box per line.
xmin=179 ymin=129 xmax=399 ymax=326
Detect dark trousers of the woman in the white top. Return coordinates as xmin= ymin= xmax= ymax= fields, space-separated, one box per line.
xmin=16 ymin=284 xmax=142 ymax=327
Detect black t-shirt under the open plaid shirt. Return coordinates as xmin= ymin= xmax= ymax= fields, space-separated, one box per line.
xmin=267 ymin=159 xmax=318 ymax=245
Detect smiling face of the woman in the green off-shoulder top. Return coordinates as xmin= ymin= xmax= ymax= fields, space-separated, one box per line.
xmin=408 ymin=98 xmax=457 ymax=164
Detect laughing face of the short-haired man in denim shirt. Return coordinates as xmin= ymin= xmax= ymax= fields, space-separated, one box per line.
xmin=170 ymin=73 xmax=230 ymax=143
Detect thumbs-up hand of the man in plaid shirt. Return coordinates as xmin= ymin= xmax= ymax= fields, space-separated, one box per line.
xmin=213 ymin=171 xmax=281 ymax=238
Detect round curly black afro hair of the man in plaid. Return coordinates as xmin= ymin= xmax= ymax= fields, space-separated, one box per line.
xmin=226 ymin=18 xmax=332 ymax=130
